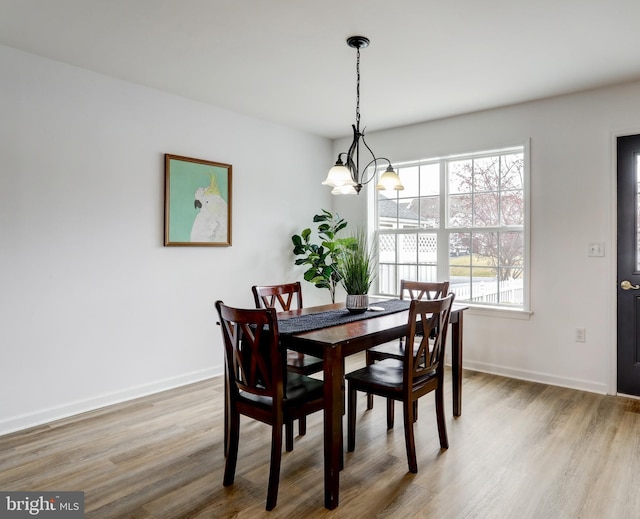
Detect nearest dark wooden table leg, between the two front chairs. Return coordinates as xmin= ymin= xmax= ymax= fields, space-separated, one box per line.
xmin=323 ymin=347 xmax=344 ymax=510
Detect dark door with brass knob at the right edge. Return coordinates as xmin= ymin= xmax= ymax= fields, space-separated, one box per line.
xmin=617 ymin=135 xmax=640 ymax=396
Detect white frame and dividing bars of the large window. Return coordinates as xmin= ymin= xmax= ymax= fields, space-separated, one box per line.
xmin=368 ymin=140 xmax=531 ymax=317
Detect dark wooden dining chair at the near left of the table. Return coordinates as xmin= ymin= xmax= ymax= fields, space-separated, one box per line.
xmin=216 ymin=301 xmax=324 ymax=510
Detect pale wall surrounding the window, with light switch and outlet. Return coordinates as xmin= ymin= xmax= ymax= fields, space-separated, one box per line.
xmin=334 ymin=83 xmax=640 ymax=393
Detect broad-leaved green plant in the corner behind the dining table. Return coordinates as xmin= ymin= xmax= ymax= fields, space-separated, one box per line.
xmin=291 ymin=209 xmax=353 ymax=303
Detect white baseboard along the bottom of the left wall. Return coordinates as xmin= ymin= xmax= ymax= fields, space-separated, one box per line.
xmin=0 ymin=366 xmax=222 ymax=436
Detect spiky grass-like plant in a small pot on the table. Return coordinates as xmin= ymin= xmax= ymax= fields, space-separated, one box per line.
xmin=337 ymin=229 xmax=376 ymax=313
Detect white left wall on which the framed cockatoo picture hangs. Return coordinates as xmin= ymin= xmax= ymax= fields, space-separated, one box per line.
xmin=0 ymin=47 xmax=332 ymax=433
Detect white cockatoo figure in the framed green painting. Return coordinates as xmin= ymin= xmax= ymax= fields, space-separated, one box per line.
xmin=191 ymin=173 xmax=228 ymax=243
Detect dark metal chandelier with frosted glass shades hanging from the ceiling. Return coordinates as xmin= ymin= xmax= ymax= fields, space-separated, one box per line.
xmin=322 ymin=36 xmax=404 ymax=195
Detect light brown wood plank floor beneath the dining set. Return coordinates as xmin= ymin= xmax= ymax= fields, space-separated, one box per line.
xmin=0 ymin=358 xmax=640 ymax=519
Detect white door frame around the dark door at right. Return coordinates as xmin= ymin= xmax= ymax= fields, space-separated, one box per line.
xmin=607 ymin=127 xmax=640 ymax=398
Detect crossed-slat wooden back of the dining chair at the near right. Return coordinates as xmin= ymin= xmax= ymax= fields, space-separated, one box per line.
xmin=404 ymin=294 xmax=455 ymax=381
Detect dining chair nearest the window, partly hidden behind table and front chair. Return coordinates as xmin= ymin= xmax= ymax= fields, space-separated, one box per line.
xmin=365 ymin=279 xmax=449 ymax=429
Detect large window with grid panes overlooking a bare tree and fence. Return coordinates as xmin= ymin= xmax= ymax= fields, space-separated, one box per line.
xmin=375 ymin=146 xmax=528 ymax=310
